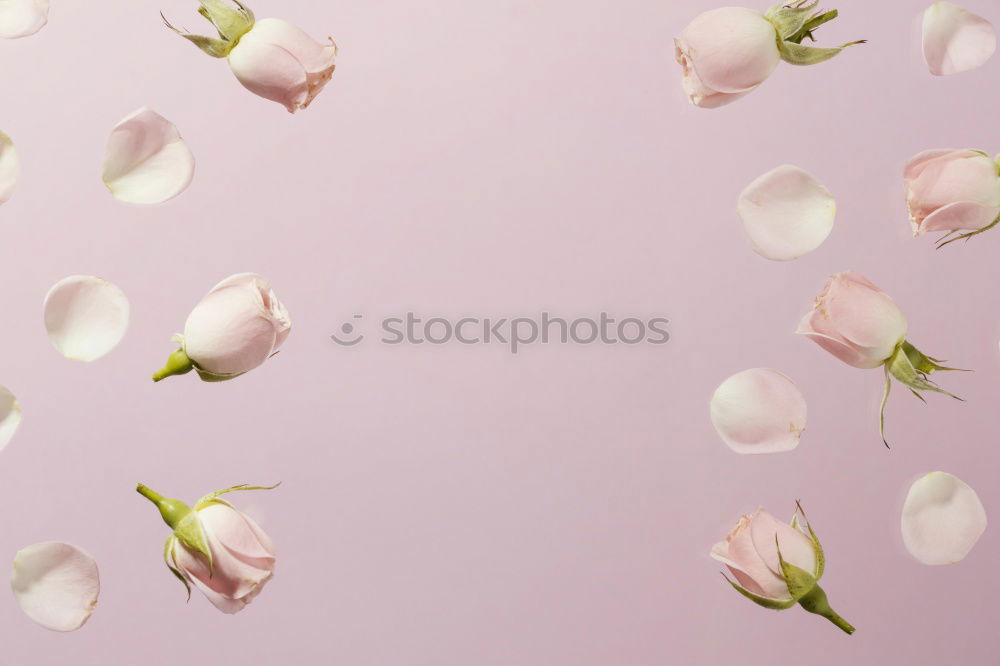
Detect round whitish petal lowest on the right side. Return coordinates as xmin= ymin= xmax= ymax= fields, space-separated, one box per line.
xmin=901 ymin=472 xmax=986 ymax=564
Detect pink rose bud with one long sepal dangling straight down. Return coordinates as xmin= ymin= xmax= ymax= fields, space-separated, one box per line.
xmin=796 ymin=271 xmax=957 ymax=446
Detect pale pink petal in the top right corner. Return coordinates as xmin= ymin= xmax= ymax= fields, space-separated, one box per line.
xmin=923 ymin=2 xmax=997 ymax=76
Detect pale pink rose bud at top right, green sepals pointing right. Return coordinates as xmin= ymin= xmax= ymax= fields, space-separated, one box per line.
xmin=674 ymin=1 xmax=860 ymax=108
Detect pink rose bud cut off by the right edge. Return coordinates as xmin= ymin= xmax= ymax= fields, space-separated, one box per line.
xmin=903 ymin=149 xmax=1000 ymax=247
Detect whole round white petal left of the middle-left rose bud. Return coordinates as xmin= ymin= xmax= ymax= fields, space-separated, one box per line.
xmin=44 ymin=275 xmax=129 ymax=361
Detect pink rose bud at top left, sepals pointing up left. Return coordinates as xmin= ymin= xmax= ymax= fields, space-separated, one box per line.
xmin=167 ymin=0 xmax=337 ymax=113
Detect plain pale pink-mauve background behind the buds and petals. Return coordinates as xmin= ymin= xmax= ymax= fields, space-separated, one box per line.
xmin=0 ymin=0 xmax=1000 ymax=666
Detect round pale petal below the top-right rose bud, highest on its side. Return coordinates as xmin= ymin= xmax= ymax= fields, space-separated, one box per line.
xmin=736 ymin=164 xmax=837 ymax=261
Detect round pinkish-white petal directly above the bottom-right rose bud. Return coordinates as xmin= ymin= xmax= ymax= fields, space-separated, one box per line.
xmin=710 ymin=368 xmax=806 ymax=453
